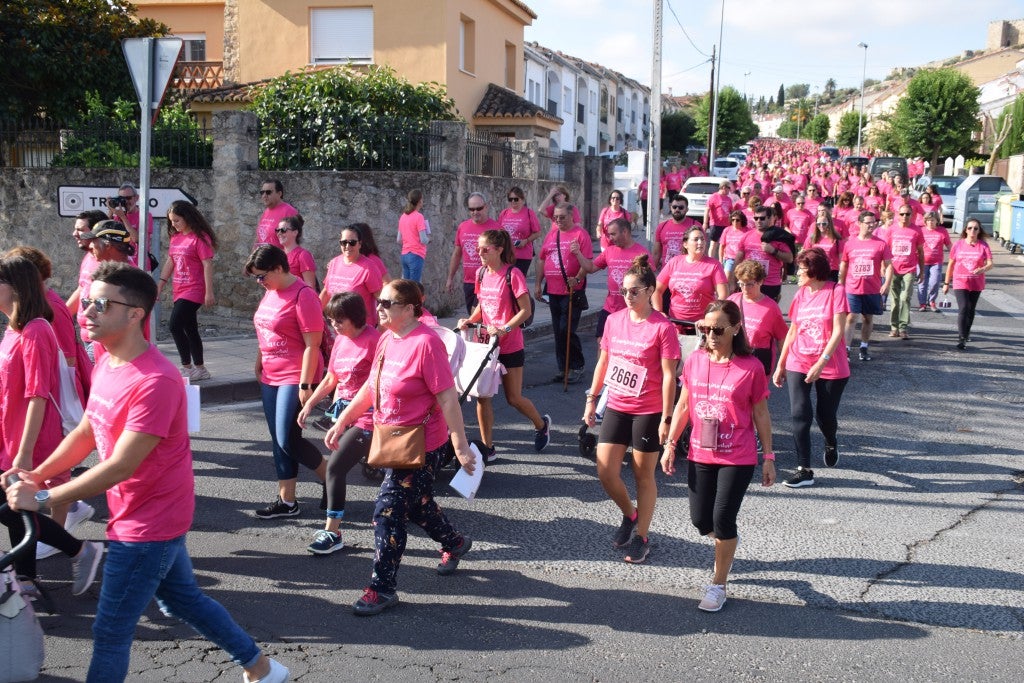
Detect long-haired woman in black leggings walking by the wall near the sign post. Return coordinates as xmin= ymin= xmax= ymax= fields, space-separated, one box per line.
xmin=157 ymin=200 xmax=217 ymax=382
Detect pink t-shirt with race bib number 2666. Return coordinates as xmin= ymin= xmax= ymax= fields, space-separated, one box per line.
xmin=601 ymin=309 xmax=682 ymax=413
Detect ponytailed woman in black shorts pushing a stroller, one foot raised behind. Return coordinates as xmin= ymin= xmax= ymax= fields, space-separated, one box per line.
xmin=458 ymin=230 xmax=551 ymax=463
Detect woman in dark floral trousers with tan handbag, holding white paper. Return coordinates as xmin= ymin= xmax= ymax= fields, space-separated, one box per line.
xmin=325 ymin=278 xmax=477 ymax=616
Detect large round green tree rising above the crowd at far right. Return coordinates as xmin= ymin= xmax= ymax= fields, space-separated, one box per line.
xmin=892 ymin=69 xmax=979 ymax=166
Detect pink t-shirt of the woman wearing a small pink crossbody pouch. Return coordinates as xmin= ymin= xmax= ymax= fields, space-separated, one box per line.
xmin=683 ymin=349 xmax=768 ymax=465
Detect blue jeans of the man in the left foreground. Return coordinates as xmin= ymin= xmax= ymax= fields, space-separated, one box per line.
xmin=85 ymin=536 xmax=260 ymax=683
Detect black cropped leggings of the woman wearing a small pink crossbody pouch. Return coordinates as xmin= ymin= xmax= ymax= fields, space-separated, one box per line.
xmin=686 ymin=460 xmax=754 ymax=541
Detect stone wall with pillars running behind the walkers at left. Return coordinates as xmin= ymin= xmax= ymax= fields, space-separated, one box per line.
xmin=0 ymin=112 xmax=613 ymax=318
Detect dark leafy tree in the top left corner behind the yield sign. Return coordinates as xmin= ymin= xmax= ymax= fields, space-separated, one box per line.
xmin=0 ymin=0 xmax=169 ymax=119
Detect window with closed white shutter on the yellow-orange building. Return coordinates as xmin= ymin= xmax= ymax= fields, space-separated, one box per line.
xmin=309 ymin=7 xmax=374 ymax=65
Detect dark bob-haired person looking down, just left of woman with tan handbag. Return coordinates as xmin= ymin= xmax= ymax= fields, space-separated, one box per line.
xmin=298 ymin=292 xmax=381 ymax=555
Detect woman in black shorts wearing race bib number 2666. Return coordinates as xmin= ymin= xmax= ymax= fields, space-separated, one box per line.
xmin=583 ymin=254 xmax=681 ymax=564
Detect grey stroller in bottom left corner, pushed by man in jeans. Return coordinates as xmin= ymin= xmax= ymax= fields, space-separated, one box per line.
xmin=0 ymin=503 xmax=45 ymax=683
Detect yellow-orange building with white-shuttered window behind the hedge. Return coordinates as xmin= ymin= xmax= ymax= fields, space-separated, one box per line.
xmin=134 ymin=0 xmax=537 ymax=121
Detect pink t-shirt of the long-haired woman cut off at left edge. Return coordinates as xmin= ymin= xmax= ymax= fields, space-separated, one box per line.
xmin=0 ymin=317 xmax=63 ymax=470
